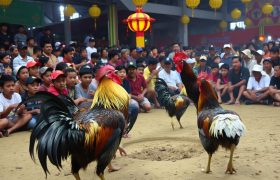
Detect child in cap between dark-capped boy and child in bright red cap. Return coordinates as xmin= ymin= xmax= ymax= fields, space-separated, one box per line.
xmin=39 ymin=67 xmax=53 ymax=91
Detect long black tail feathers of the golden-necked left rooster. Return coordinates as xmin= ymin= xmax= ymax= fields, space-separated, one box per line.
xmin=28 ymin=93 xmax=85 ymax=175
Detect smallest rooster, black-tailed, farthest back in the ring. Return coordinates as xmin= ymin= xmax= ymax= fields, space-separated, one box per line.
xmin=155 ymin=78 xmax=190 ymax=130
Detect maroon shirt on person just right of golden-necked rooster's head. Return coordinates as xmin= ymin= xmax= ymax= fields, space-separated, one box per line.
xmin=127 ymin=74 xmax=147 ymax=96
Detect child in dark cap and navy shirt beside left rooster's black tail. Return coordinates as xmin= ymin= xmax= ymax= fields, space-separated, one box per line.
xmin=21 ymin=76 xmax=41 ymax=129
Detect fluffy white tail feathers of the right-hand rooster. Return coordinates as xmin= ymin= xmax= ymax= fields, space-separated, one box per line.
xmin=209 ymin=114 xmax=246 ymax=138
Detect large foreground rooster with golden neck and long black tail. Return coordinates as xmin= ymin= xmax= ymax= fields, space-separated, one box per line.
xmin=19 ymin=66 xmax=129 ymax=180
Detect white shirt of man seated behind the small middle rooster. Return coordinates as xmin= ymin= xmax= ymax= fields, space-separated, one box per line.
xmin=158 ymin=70 xmax=182 ymax=88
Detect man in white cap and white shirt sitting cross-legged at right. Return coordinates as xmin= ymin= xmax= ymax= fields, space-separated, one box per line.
xmin=243 ymin=64 xmax=270 ymax=105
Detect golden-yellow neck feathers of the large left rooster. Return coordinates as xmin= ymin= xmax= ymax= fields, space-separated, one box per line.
xmin=91 ymin=77 xmax=129 ymax=111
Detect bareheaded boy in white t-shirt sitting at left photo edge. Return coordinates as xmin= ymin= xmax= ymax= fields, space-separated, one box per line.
xmin=0 ymin=75 xmax=31 ymax=136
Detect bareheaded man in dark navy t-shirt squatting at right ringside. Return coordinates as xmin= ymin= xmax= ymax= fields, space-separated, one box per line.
xmin=226 ymin=56 xmax=250 ymax=104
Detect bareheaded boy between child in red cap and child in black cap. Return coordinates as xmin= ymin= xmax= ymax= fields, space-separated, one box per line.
xmin=64 ymin=68 xmax=86 ymax=105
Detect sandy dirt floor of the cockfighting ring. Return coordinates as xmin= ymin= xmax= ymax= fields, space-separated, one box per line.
xmin=0 ymin=105 xmax=280 ymax=180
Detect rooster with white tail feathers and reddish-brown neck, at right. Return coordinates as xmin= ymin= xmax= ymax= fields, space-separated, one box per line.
xmin=197 ymin=75 xmax=245 ymax=174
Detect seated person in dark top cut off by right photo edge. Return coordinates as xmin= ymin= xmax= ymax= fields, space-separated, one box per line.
xmin=268 ymin=65 xmax=280 ymax=106
